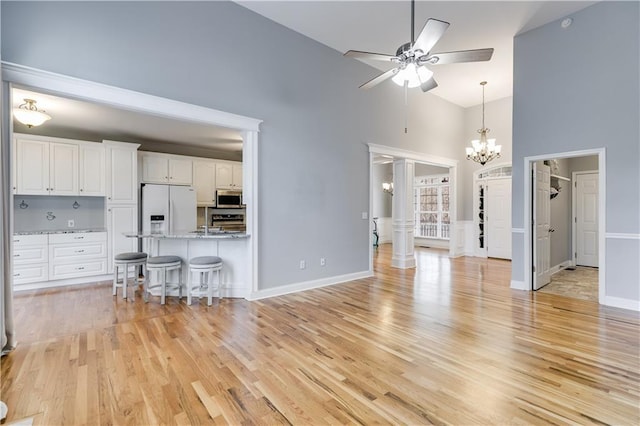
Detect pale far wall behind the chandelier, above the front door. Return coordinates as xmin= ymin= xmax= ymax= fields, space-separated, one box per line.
xmin=458 ymin=96 xmax=513 ymax=220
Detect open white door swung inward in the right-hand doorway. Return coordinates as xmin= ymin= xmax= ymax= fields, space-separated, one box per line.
xmin=532 ymin=161 xmax=551 ymax=290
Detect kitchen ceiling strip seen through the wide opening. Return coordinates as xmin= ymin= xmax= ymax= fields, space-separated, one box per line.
xmin=12 ymin=88 xmax=242 ymax=155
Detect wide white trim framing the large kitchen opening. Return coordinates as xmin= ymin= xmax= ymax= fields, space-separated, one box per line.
xmin=1 ymin=61 xmax=262 ymax=299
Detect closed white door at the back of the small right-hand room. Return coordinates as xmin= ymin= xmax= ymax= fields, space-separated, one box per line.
xmin=575 ymin=173 xmax=598 ymax=267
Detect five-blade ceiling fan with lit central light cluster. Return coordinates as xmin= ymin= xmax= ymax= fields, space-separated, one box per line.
xmin=344 ymin=0 xmax=493 ymax=92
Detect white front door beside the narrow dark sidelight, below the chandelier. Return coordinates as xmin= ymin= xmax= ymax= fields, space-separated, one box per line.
xmin=484 ymin=179 xmax=511 ymax=259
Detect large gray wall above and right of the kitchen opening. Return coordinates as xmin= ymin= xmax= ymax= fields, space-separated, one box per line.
xmin=0 ymin=1 xmax=466 ymax=289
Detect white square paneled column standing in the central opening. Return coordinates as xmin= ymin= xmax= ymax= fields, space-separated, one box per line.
xmin=391 ymin=159 xmax=416 ymax=269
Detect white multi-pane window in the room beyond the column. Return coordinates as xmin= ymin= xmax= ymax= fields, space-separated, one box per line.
xmin=413 ymin=175 xmax=451 ymax=240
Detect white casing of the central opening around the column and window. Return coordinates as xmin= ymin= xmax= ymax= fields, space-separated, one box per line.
xmin=367 ymin=143 xmax=461 ymax=274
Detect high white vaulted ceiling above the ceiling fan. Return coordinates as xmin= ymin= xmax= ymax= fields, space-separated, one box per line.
xmin=237 ymin=0 xmax=596 ymax=108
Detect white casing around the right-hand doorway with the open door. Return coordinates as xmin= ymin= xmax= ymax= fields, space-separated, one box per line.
xmin=524 ymin=148 xmax=607 ymax=305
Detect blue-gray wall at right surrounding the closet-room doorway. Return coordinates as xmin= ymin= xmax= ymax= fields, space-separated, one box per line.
xmin=512 ymin=2 xmax=640 ymax=301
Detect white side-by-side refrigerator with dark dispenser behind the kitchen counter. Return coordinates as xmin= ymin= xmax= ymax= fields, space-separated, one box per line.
xmin=141 ymin=184 xmax=197 ymax=234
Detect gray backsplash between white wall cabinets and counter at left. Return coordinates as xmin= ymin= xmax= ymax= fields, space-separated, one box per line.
xmin=13 ymin=195 xmax=105 ymax=232
